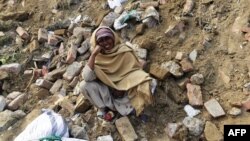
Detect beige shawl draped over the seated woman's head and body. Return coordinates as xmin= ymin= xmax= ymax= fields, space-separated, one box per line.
xmin=90 ymin=27 xmax=152 ymax=115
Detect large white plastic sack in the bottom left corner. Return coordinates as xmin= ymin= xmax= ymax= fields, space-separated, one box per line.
xmin=14 ymin=109 xmax=69 ymax=141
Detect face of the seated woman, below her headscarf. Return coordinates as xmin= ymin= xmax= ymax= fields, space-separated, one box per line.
xmin=97 ymin=36 xmax=114 ymax=50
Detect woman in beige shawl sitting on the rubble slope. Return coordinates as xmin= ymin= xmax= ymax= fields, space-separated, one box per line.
xmin=81 ymin=27 xmax=156 ymax=120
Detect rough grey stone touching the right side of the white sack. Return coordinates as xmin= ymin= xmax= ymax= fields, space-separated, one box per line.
xmin=70 ymin=125 xmax=89 ymax=140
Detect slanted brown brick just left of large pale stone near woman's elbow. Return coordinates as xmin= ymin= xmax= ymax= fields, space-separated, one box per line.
xmin=45 ymin=67 xmax=66 ymax=82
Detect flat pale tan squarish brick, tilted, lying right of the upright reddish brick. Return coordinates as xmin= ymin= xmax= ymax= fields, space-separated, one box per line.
xmin=204 ymin=98 xmax=225 ymax=118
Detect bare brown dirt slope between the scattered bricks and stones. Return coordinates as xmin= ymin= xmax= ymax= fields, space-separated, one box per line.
xmin=0 ymin=0 xmax=250 ymax=141
